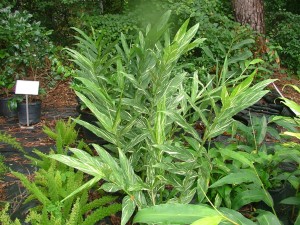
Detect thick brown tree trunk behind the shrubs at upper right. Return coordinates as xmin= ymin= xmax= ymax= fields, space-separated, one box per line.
xmin=233 ymin=0 xmax=265 ymax=34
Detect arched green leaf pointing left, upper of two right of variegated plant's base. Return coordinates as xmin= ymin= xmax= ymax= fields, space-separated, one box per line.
xmin=210 ymin=169 xmax=260 ymax=188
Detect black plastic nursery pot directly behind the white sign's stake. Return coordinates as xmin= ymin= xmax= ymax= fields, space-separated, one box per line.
xmin=18 ymin=101 xmax=42 ymax=125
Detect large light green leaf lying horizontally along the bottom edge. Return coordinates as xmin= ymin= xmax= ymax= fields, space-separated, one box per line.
xmin=133 ymin=204 xmax=220 ymax=224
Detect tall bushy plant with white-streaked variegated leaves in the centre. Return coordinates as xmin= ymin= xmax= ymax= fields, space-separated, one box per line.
xmin=51 ymin=11 xmax=272 ymax=224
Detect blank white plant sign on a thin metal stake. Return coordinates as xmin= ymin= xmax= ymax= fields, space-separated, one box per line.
xmin=15 ymin=80 xmax=40 ymax=128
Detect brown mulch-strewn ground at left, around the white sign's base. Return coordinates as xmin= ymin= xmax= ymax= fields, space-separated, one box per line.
xmin=0 ymin=80 xmax=78 ymax=214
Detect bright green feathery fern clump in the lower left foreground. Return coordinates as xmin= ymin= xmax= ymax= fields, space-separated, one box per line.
xmin=12 ymin=148 xmax=121 ymax=224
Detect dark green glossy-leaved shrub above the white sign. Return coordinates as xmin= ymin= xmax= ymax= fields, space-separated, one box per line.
xmin=0 ymin=7 xmax=52 ymax=85
